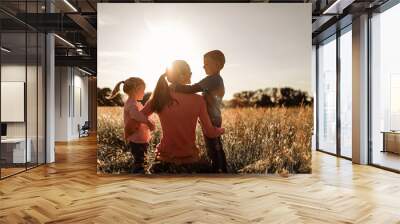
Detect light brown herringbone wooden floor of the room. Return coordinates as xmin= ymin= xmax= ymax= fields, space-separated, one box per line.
xmin=0 ymin=138 xmax=400 ymax=224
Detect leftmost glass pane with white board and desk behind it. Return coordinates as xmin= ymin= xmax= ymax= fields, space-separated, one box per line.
xmin=0 ymin=32 xmax=27 ymax=177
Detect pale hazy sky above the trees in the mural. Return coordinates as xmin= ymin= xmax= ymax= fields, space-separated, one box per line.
xmin=97 ymin=3 xmax=312 ymax=99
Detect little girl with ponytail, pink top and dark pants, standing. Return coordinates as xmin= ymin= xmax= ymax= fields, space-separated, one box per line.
xmin=110 ymin=77 xmax=154 ymax=173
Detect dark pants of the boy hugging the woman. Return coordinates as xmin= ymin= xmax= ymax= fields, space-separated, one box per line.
xmin=204 ymin=121 xmax=227 ymax=173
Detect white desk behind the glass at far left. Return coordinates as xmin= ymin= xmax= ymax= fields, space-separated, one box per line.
xmin=1 ymin=138 xmax=32 ymax=163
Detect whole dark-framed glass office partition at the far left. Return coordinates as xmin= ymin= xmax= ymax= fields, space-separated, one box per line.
xmin=0 ymin=1 xmax=46 ymax=179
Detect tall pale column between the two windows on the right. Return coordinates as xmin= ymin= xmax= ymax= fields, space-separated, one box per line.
xmin=352 ymin=14 xmax=368 ymax=164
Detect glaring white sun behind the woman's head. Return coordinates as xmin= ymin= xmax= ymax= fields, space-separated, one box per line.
xmin=132 ymin=20 xmax=203 ymax=90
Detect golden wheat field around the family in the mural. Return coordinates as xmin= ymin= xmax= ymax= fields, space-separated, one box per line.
xmin=97 ymin=107 xmax=313 ymax=175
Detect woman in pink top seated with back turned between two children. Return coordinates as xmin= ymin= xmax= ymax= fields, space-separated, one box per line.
xmin=142 ymin=60 xmax=224 ymax=167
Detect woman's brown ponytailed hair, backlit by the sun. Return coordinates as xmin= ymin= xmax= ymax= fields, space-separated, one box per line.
xmin=149 ymin=60 xmax=190 ymax=113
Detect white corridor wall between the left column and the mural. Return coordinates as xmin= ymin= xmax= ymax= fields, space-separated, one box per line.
xmin=55 ymin=67 xmax=88 ymax=141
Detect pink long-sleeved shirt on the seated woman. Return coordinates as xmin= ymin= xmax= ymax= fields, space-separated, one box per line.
xmin=142 ymin=92 xmax=223 ymax=163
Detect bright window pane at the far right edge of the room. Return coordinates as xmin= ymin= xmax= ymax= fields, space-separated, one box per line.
xmin=370 ymin=4 xmax=400 ymax=170
